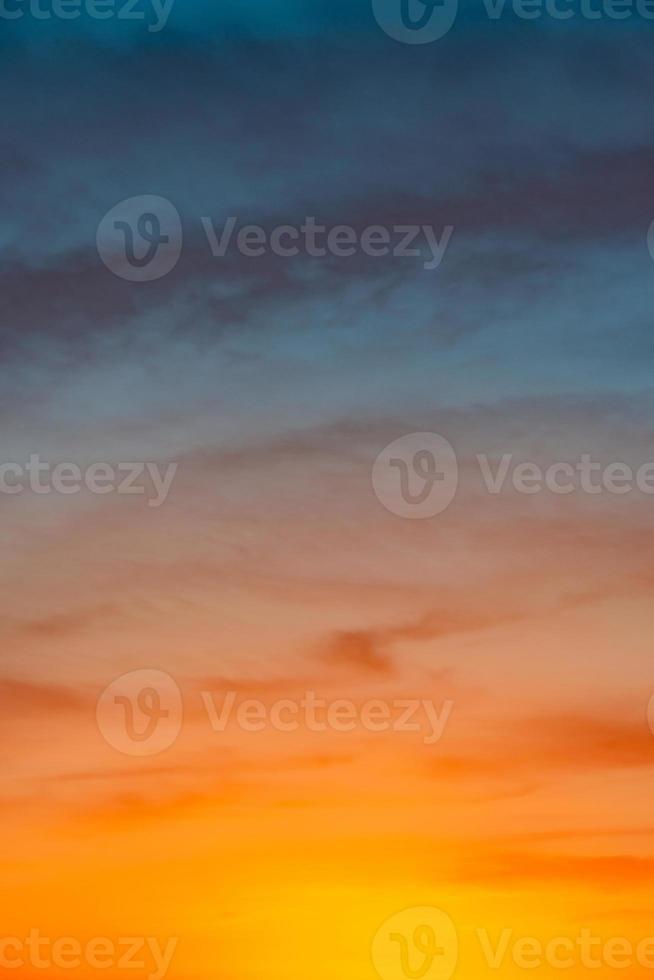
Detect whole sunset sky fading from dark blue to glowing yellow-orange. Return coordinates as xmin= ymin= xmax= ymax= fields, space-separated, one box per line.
xmin=0 ymin=0 xmax=654 ymax=980
